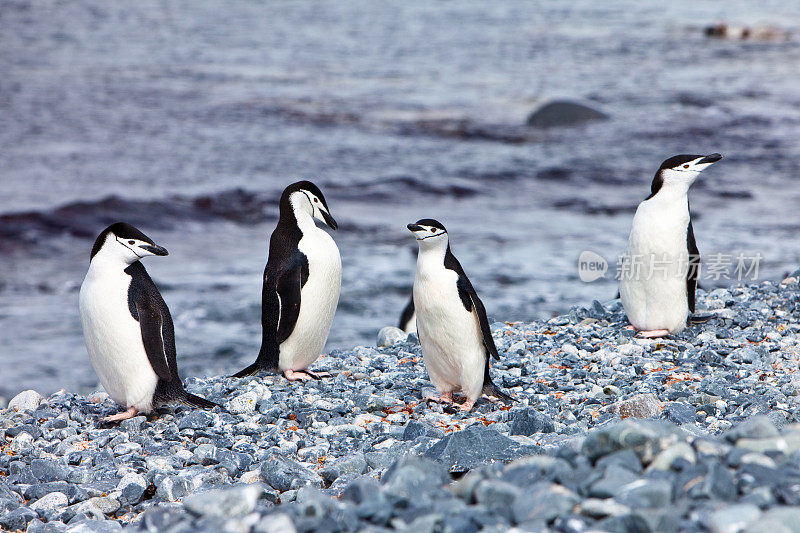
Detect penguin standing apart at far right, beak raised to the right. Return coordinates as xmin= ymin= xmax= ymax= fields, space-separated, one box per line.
xmin=619 ymin=154 xmax=722 ymax=338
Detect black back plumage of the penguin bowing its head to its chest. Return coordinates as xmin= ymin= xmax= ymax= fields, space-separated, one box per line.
xmin=234 ymin=185 xmax=312 ymax=377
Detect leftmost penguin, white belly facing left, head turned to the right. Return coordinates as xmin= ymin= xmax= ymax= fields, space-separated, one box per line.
xmin=78 ymin=222 xmax=217 ymax=422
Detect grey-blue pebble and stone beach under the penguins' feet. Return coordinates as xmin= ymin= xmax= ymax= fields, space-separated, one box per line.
xmin=0 ymin=271 xmax=800 ymax=533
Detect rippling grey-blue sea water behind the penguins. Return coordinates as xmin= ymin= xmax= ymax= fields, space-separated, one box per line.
xmin=0 ymin=0 xmax=800 ymax=397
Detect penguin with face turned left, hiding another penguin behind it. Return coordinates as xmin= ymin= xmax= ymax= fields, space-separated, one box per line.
xmin=407 ymin=218 xmax=513 ymax=411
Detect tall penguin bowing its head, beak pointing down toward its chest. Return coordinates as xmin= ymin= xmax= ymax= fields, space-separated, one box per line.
xmin=234 ymin=181 xmax=342 ymax=381
